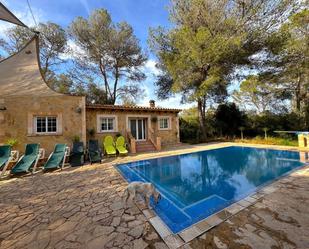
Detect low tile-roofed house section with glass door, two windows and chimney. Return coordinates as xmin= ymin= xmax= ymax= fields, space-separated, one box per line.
xmin=86 ymin=101 xmax=180 ymax=152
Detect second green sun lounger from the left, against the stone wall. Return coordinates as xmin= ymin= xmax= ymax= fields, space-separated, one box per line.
xmin=11 ymin=144 xmax=40 ymax=174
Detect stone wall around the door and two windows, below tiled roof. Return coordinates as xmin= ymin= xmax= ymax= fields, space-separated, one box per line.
xmin=86 ymin=108 xmax=179 ymax=146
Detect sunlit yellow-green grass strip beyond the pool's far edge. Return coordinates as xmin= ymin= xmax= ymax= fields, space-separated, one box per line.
xmin=234 ymin=136 xmax=298 ymax=147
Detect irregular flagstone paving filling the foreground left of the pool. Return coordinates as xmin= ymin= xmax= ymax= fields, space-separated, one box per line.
xmin=0 ymin=164 xmax=167 ymax=249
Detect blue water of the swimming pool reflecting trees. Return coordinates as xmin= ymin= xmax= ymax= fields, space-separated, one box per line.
xmin=117 ymin=146 xmax=304 ymax=233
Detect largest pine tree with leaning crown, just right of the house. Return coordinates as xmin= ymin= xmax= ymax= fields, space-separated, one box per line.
xmin=149 ymin=0 xmax=293 ymax=140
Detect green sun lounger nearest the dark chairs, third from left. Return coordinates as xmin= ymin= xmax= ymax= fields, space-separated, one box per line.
xmin=44 ymin=144 xmax=69 ymax=170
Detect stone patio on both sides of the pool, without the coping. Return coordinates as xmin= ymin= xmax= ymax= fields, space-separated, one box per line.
xmin=0 ymin=143 xmax=309 ymax=249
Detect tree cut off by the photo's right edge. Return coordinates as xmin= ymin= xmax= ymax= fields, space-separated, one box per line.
xmin=261 ymin=9 xmax=309 ymax=112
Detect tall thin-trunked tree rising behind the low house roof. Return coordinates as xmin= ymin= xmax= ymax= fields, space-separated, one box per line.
xmin=70 ymin=9 xmax=147 ymax=104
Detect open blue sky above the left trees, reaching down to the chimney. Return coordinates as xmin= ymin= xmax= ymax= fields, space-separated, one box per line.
xmin=0 ymin=0 xmax=195 ymax=108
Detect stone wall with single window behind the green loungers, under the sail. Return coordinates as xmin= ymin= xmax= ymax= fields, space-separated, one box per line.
xmin=0 ymin=95 xmax=86 ymax=154
